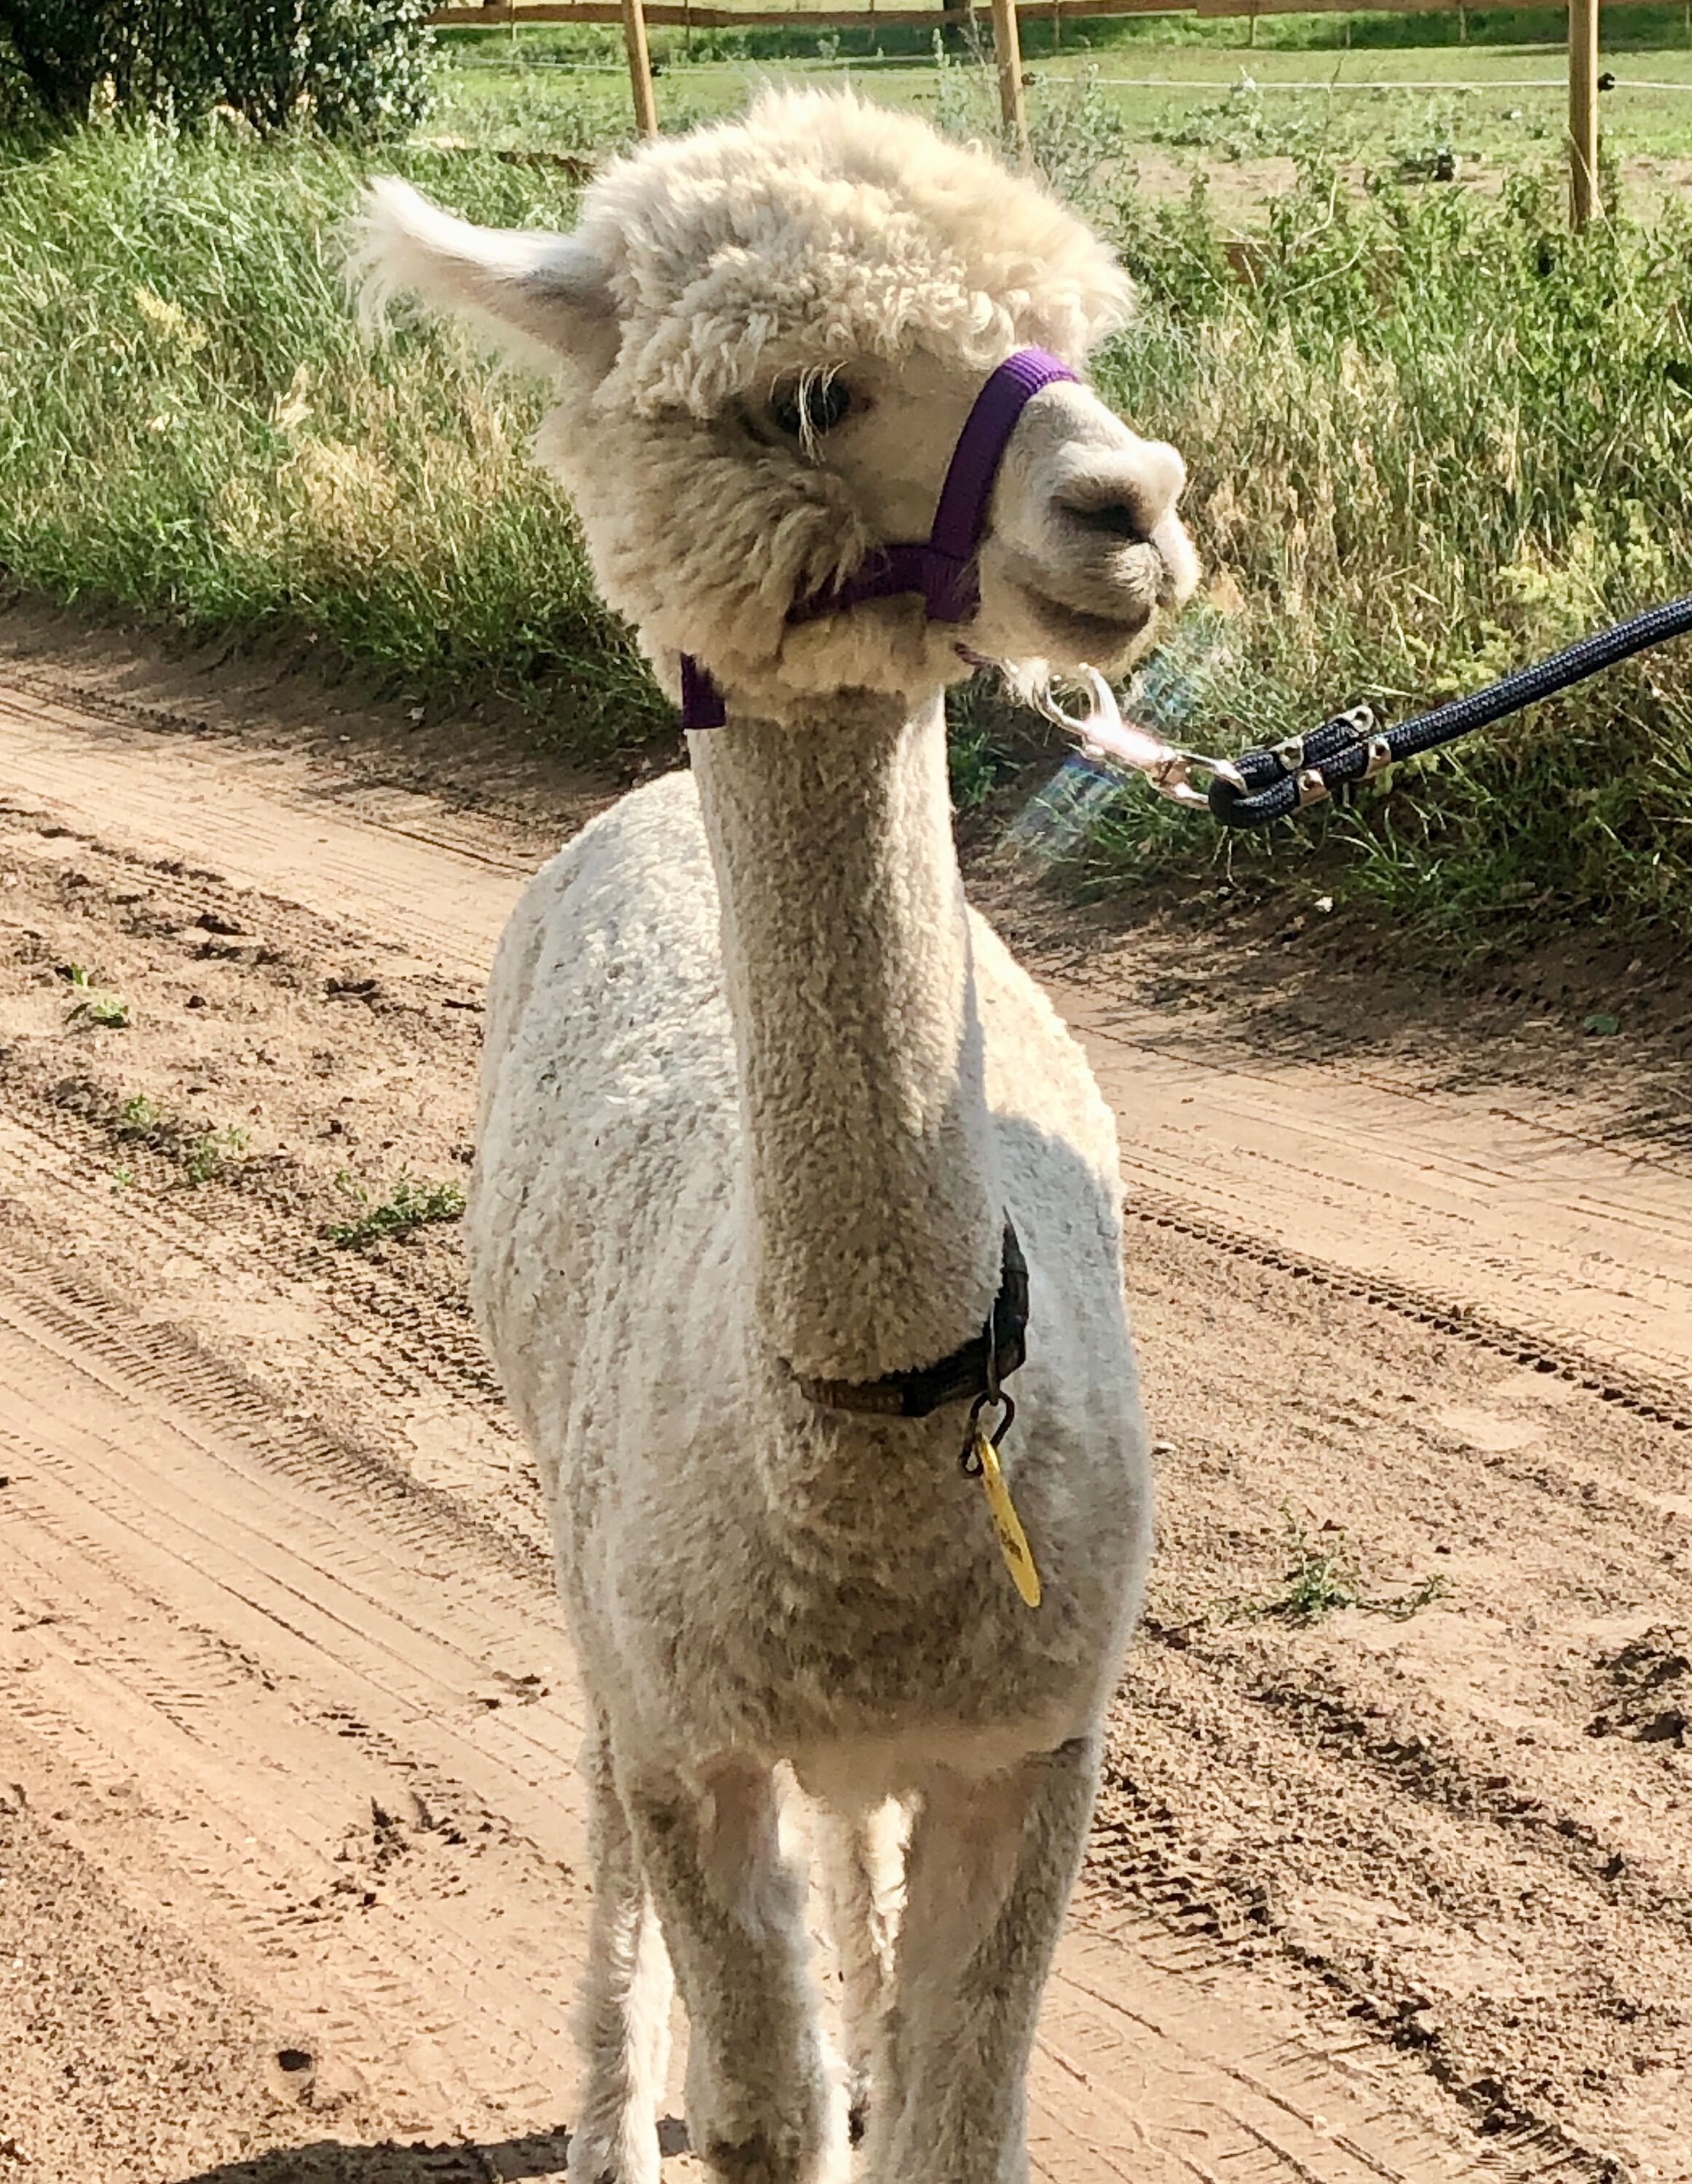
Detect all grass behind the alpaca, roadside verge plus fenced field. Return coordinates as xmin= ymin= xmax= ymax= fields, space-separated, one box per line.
xmin=0 ymin=21 xmax=1692 ymax=952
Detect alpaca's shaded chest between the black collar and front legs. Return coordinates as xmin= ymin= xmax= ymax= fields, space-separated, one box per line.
xmin=579 ymin=1437 xmax=1144 ymax=1773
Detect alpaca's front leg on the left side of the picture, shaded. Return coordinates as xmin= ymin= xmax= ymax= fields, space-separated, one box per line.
xmin=625 ymin=1762 xmax=832 ymax=2184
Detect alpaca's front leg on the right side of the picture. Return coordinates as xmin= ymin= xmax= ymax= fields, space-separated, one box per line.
xmin=866 ymin=1736 xmax=1098 ymax=2184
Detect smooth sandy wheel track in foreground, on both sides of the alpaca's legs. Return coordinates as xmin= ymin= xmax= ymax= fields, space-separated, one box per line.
xmin=0 ymin=1243 xmax=1519 ymax=2184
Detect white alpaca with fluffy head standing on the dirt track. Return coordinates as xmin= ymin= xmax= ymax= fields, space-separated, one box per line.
xmin=367 ymin=96 xmax=1194 ymax=2184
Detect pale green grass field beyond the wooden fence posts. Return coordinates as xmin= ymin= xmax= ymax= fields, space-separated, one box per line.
xmin=430 ymin=33 xmax=1692 ymax=234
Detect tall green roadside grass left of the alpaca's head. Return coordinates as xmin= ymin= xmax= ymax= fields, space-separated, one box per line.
xmin=0 ymin=131 xmax=662 ymax=753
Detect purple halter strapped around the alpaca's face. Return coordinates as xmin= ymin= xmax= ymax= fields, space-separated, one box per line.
xmin=681 ymin=349 xmax=1076 ymax=727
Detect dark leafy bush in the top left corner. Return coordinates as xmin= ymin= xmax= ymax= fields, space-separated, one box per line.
xmin=0 ymin=0 xmax=428 ymax=135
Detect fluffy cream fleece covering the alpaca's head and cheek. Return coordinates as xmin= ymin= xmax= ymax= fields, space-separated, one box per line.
xmin=357 ymin=94 xmax=1179 ymax=708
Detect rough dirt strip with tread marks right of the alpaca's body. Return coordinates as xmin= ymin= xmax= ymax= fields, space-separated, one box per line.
xmin=1078 ymin=1232 xmax=1692 ymax=2177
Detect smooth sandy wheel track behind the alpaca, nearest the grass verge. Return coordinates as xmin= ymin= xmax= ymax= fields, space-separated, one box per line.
xmin=0 ymin=664 xmax=1692 ymax=1420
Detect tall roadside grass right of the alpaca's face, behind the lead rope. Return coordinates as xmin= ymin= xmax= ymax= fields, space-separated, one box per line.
xmin=1080 ymin=166 xmax=1692 ymax=952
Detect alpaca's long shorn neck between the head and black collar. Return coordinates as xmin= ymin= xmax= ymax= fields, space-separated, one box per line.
xmin=692 ymin=699 xmax=1004 ymax=1380
